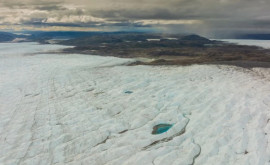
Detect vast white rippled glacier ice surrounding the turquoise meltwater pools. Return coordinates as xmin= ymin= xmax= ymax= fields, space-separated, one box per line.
xmin=0 ymin=43 xmax=270 ymax=165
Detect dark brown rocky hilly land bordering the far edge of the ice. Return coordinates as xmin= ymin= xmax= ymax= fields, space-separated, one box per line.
xmin=57 ymin=34 xmax=270 ymax=67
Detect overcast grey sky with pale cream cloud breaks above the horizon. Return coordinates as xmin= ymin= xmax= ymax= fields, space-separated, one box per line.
xmin=0 ymin=0 xmax=270 ymax=36
